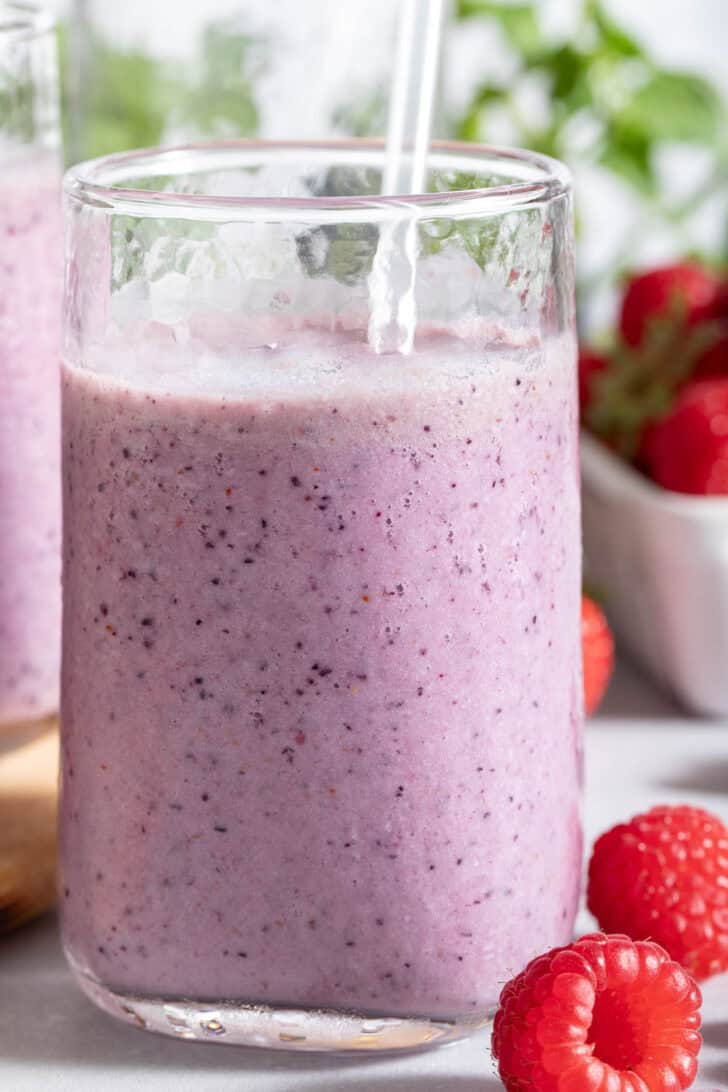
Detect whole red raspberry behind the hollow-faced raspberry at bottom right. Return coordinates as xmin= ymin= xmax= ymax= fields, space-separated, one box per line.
xmin=588 ymin=806 xmax=728 ymax=978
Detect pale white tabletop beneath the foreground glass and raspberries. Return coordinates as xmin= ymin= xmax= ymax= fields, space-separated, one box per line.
xmin=0 ymin=666 xmax=728 ymax=1092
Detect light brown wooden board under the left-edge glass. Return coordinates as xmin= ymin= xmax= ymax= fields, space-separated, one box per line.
xmin=0 ymin=721 xmax=58 ymax=933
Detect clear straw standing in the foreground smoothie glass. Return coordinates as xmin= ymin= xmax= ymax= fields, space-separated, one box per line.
xmin=368 ymin=0 xmax=445 ymax=353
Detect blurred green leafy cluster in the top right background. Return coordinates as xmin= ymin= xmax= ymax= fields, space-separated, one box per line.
xmin=454 ymin=0 xmax=727 ymax=205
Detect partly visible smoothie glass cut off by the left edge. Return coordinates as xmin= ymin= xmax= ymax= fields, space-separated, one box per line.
xmin=0 ymin=2 xmax=62 ymax=724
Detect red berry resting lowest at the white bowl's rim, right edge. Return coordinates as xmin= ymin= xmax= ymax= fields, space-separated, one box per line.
xmin=640 ymin=377 xmax=728 ymax=496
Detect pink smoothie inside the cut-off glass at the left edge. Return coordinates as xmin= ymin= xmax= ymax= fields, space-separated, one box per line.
xmin=0 ymin=158 xmax=62 ymax=723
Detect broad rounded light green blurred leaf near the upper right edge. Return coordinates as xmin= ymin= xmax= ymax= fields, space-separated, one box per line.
xmin=619 ymin=71 xmax=725 ymax=144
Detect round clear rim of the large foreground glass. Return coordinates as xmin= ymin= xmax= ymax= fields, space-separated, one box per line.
xmin=63 ymin=140 xmax=571 ymax=224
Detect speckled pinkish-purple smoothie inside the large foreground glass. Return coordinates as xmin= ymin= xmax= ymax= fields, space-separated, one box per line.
xmin=61 ymin=331 xmax=581 ymax=1017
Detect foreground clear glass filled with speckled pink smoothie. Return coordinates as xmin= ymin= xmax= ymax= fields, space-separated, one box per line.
xmin=60 ymin=142 xmax=582 ymax=1049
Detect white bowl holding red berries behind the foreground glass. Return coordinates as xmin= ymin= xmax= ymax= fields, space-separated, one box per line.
xmin=582 ymin=432 xmax=728 ymax=715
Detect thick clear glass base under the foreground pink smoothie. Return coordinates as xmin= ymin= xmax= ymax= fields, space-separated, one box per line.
xmin=73 ymin=969 xmax=493 ymax=1054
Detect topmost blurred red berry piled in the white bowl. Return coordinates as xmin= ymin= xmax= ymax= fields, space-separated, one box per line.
xmin=619 ymin=262 xmax=721 ymax=347
